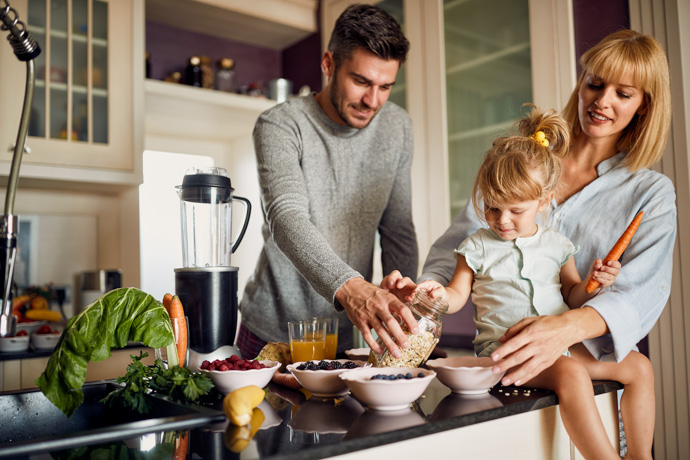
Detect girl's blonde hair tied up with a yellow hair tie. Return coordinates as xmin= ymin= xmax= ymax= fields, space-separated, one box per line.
xmin=472 ymin=104 xmax=570 ymax=218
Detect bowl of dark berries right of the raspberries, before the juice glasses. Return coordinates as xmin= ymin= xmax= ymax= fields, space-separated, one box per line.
xmin=287 ymin=359 xmax=371 ymax=398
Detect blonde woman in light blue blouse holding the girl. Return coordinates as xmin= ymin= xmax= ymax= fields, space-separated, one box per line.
xmin=382 ymin=30 xmax=676 ymax=458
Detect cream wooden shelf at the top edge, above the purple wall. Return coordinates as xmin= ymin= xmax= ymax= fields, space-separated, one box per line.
xmin=146 ymin=0 xmax=318 ymax=50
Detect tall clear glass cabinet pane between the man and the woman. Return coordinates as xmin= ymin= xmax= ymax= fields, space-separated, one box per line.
xmin=443 ymin=0 xmax=533 ymax=219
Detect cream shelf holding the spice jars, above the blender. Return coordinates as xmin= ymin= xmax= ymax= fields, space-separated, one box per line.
xmin=144 ymin=80 xmax=276 ymax=141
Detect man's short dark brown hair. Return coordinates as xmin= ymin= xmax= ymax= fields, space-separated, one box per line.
xmin=328 ymin=4 xmax=410 ymax=69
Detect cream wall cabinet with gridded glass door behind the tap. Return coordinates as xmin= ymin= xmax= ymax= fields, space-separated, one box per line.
xmin=0 ymin=0 xmax=143 ymax=183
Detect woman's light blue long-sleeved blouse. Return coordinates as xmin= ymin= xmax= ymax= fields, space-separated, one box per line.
xmin=419 ymin=152 xmax=677 ymax=361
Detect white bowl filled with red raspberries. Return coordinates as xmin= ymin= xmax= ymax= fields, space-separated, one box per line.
xmin=199 ymin=355 xmax=280 ymax=394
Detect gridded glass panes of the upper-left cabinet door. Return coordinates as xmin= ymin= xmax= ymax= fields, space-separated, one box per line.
xmin=27 ymin=0 xmax=109 ymax=144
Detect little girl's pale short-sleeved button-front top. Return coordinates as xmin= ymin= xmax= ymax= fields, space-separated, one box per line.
xmin=455 ymin=226 xmax=577 ymax=356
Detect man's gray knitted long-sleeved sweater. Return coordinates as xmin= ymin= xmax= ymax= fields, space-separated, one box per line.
xmin=240 ymin=95 xmax=418 ymax=352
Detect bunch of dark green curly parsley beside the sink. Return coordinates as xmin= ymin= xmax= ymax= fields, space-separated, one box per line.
xmin=102 ymin=352 xmax=214 ymax=414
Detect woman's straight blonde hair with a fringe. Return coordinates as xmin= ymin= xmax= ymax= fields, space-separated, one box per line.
xmin=563 ymin=30 xmax=671 ymax=172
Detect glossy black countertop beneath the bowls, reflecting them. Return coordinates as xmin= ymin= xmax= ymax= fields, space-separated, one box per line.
xmin=10 ymin=379 xmax=622 ymax=460
